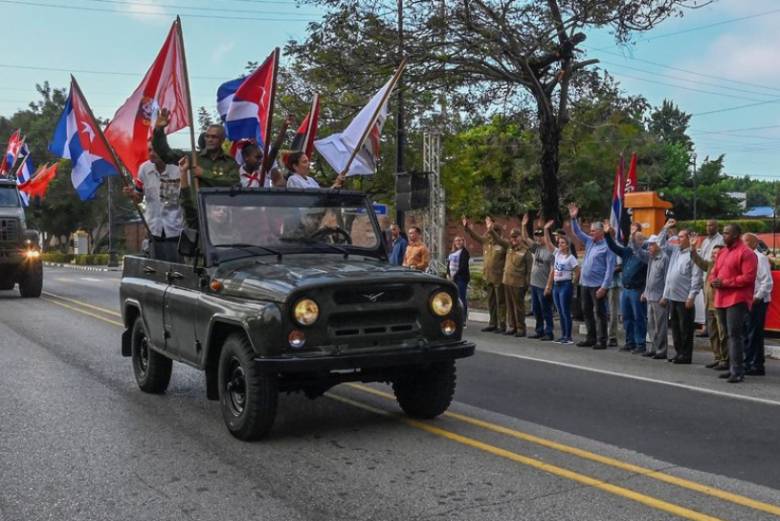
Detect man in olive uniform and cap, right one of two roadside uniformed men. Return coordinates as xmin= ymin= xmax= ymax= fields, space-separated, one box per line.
xmin=490 ymin=228 xmax=533 ymax=337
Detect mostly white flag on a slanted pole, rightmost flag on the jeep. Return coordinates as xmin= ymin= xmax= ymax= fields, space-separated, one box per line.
xmin=314 ymin=63 xmax=404 ymax=176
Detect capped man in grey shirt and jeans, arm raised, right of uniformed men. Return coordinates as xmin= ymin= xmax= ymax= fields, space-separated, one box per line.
xmin=520 ymin=214 xmax=554 ymax=341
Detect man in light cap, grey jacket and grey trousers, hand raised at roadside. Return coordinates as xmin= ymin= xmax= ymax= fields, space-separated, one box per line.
xmin=634 ymin=235 xmax=669 ymax=360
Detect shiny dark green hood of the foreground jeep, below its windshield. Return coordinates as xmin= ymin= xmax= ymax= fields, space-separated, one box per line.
xmin=213 ymin=255 xmax=442 ymax=302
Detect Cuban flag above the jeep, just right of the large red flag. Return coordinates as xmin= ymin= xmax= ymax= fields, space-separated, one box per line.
xmin=217 ymin=50 xmax=279 ymax=159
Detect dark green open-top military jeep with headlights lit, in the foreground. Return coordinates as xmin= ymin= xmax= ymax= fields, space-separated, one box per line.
xmin=120 ymin=188 xmax=474 ymax=440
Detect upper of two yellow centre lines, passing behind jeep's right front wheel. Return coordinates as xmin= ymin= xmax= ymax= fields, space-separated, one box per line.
xmin=349 ymin=384 xmax=780 ymax=516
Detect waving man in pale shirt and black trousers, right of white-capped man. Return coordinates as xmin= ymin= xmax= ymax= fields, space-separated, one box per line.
xmin=659 ymin=219 xmax=703 ymax=364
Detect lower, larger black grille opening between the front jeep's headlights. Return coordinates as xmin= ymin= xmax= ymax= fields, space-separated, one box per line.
xmin=328 ymin=309 xmax=420 ymax=338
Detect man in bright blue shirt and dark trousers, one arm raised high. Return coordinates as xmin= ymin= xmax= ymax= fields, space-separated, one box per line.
xmin=569 ymin=203 xmax=615 ymax=349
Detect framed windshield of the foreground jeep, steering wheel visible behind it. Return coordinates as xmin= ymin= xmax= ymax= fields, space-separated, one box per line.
xmin=201 ymin=190 xmax=384 ymax=262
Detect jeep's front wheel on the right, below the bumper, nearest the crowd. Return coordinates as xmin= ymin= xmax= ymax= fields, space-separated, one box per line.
xmin=393 ymin=360 xmax=455 ymax=419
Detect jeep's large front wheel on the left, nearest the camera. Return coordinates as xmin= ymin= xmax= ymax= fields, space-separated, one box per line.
xmin=219 ymin=334 xmax=279 ymax=441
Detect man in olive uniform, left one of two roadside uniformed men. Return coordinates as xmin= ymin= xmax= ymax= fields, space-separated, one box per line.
xmin=463 ymin=215 xmax=506 ymax=333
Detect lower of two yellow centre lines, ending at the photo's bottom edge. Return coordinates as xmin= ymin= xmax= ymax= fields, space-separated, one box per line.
xmin=327 ymin=393 xmax=720 ymax=521
